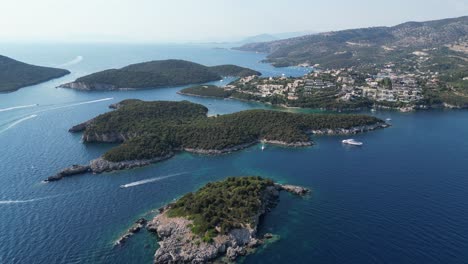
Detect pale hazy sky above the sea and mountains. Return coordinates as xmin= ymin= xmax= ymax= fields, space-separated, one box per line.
xmin=0 ymin=0 xmax=468 ymax=42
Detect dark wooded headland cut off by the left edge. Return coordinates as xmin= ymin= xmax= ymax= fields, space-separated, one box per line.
xmin=0 ymin=55 xmax=70 ymax=92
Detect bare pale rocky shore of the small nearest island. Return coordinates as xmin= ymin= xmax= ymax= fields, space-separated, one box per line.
xmin=147 ymin=184 xmax=309 ymax=263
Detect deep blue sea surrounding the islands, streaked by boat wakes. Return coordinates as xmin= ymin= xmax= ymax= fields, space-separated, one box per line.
xmin=0 ymin=44 xmax=468 ymax=263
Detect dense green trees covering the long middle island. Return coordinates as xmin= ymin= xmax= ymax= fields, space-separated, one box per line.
xmin=77 ymin=100 xmax=382 ymax=161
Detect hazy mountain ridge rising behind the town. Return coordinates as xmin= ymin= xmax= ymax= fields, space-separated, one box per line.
xmin=235 ymin=16 xmax=468 ymax=67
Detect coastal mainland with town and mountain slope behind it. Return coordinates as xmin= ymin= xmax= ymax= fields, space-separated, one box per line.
xmin=234 ymin=16 xmax=468 ymax=112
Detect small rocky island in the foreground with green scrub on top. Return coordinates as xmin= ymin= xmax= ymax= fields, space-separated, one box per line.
xmin=116 ymin=176 xmax=310 ymax=263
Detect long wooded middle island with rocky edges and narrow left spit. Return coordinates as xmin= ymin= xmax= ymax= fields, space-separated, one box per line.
xmin=46 ymin=99 xmax=388 ymax=181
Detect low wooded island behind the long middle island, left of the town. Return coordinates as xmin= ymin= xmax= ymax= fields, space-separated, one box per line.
xmin=59 ymin=60 xmax=261 ymax=91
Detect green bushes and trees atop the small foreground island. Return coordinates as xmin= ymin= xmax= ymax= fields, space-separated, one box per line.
xmin=168 ymin=177 xmax=274 ymax=242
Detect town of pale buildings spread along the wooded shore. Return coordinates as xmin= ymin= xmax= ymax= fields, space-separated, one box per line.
xmin=224 ymin=52 xmax=454 ymax=111
